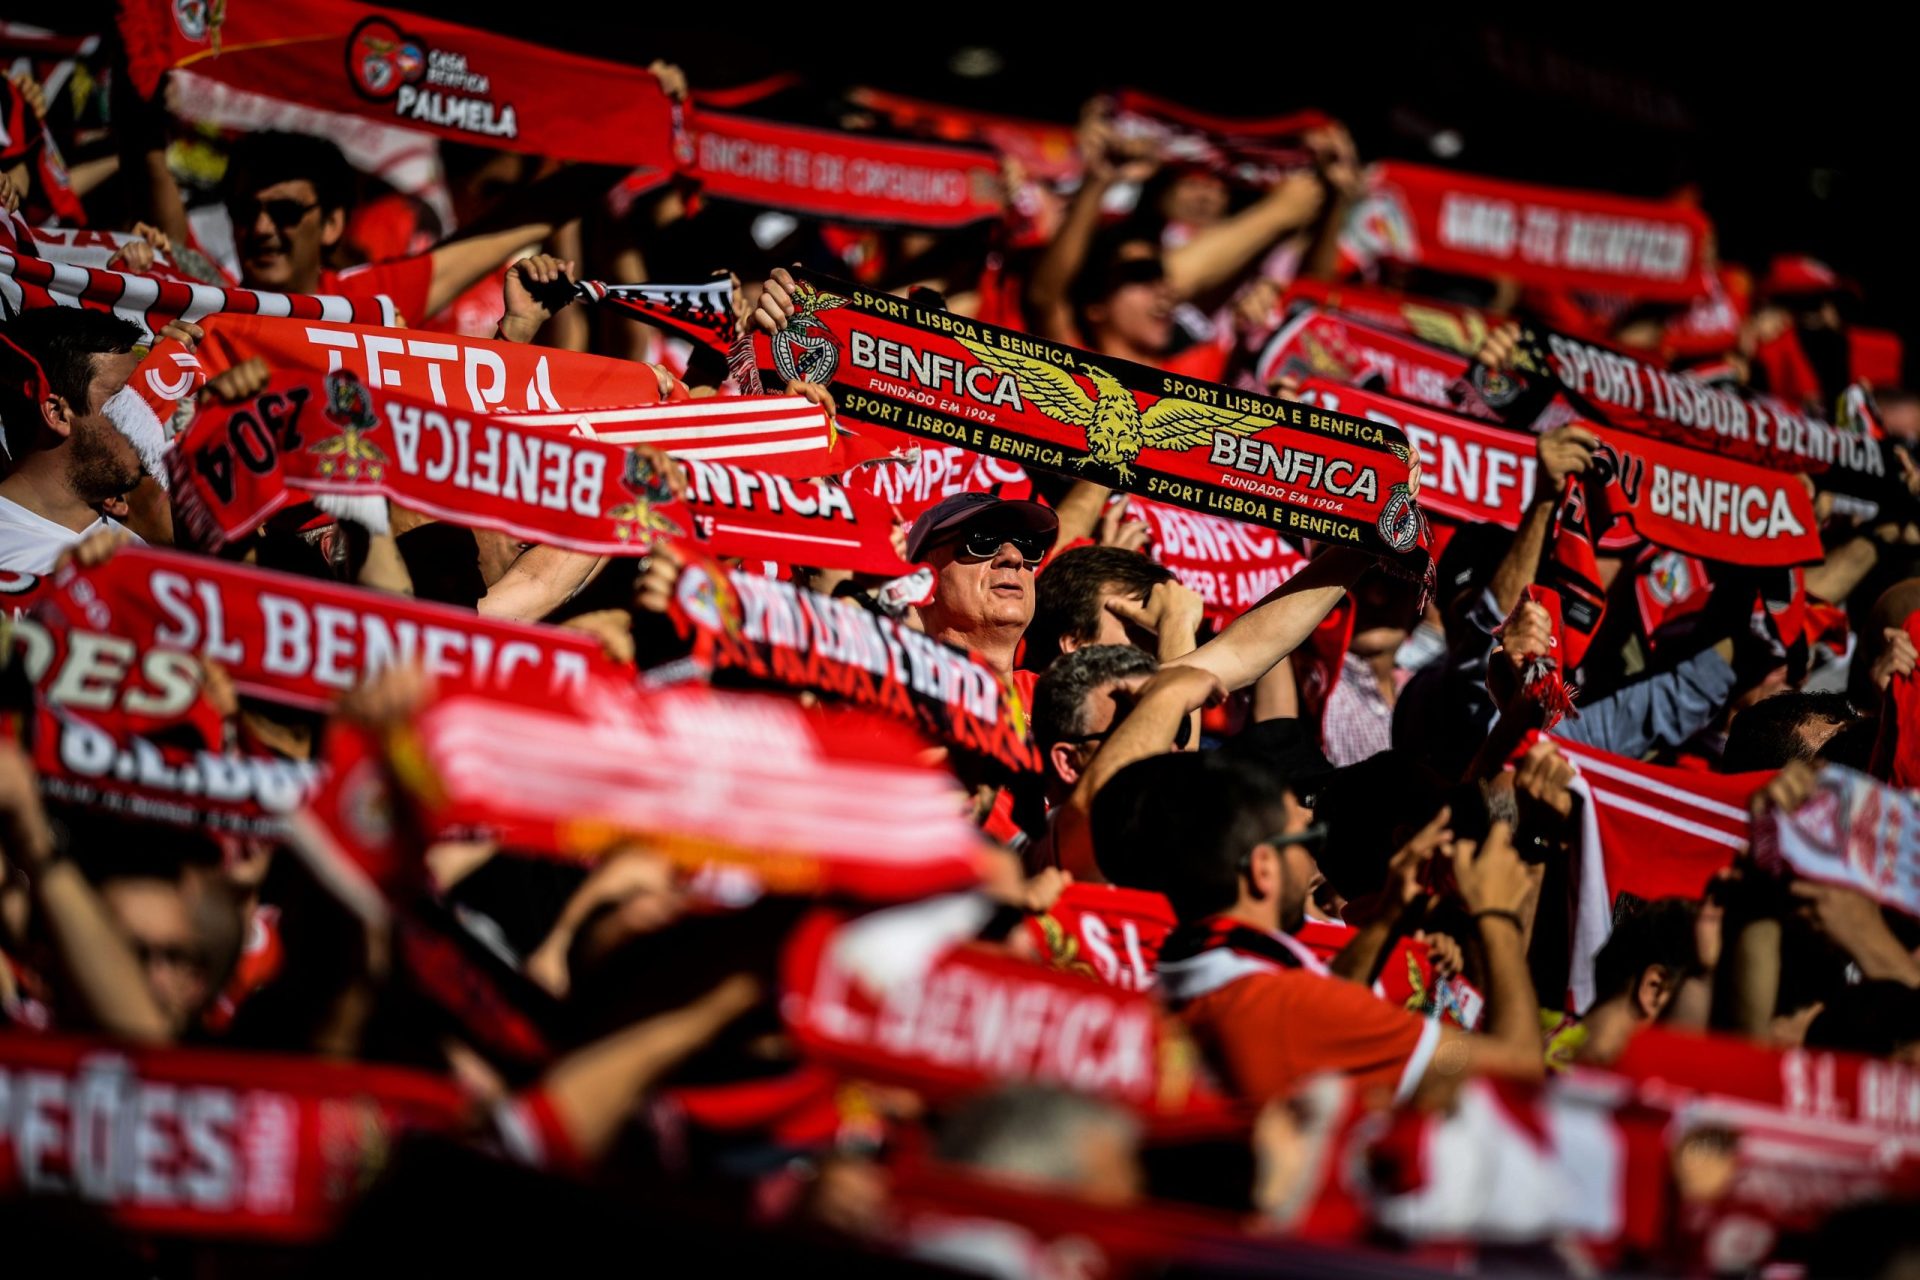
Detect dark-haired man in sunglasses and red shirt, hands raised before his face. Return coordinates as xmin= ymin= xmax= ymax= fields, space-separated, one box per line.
xmin=1144 ymin=752 xmax=1544 ymax=1102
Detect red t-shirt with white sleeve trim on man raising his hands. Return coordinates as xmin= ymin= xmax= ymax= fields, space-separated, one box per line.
xmin=1181 ymin=969 xmax=1440 ymax=1102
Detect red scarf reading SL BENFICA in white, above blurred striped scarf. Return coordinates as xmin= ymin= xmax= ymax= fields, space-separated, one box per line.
xmin=22 ymin=547 xmax=612 ymax=710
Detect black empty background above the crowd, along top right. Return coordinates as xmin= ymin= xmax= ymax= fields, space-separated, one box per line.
xmin=71 ymin=10 xmax=1920 ymax=386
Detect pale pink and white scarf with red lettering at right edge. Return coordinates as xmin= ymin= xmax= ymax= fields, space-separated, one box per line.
xmin=1753 ymin=764 xmax=1920 ymax=915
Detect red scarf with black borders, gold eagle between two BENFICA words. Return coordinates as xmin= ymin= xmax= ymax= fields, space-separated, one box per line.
xmin=735 ymin=273 xmax=1430 ymax=576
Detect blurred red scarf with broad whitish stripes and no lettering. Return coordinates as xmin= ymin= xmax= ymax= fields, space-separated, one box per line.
xmin=298 ymin=681 xmax=981 ymax=917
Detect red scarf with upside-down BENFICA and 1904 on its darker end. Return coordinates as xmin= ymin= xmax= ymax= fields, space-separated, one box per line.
xmin=167 ymin=368 xmax=691 ymax=557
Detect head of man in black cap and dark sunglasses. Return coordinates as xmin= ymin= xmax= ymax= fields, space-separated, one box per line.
xmin=906 ymin=493 xmax=1060 ymax=695
